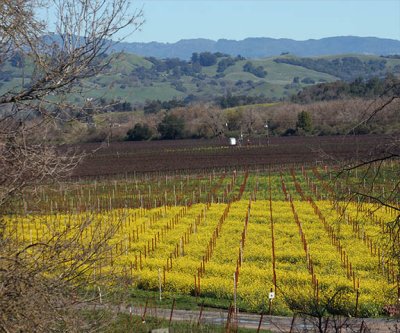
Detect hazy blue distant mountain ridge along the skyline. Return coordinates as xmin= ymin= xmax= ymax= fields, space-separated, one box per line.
xmin=114 ymin=36 xmax=400 ymax=59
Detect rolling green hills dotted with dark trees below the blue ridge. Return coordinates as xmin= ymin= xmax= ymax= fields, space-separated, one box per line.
xmin=0 ymin=53 xmax=400 ymax=108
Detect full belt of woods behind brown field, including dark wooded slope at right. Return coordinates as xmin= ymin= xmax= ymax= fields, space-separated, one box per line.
xmin=48 ymin=75 xmax=400 ymax=142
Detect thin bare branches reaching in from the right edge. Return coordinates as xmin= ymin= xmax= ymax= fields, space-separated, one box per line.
xmin=335 ymin=80 xmax=400 ymax=313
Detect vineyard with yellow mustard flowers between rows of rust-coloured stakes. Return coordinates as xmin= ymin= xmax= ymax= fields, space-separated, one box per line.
xmin=6 ymin=166 xmax=398 ymax=316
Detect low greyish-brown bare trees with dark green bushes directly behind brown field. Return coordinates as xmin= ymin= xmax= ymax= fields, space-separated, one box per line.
xmin=121 ymin=94 xmax=400 ymax=141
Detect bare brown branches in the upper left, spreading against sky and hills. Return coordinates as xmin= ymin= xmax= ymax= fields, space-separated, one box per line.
xmin=0 ymin=0 xmax=142 ymax=203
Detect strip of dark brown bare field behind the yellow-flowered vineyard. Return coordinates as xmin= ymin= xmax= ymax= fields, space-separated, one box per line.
xmin=70 ymin=136 xmax=390 ymax=177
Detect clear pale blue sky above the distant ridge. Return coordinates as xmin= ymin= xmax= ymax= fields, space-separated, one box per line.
xmin=128 ymin=0 xmax=400 ymax=42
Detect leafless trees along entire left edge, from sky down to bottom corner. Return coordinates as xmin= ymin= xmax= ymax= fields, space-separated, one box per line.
xmin=0 ymin=0 xmax=143 ymax=332
